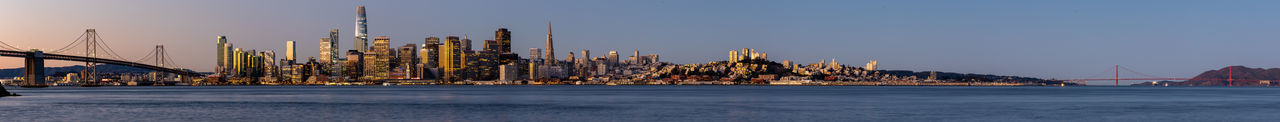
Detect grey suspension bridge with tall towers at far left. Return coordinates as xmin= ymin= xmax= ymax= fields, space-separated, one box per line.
xmin=0 ymin=28 xmax=204 ymax=87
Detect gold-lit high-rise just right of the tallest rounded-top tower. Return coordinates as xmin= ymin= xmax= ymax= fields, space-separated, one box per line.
xmin=365 ymin=36 xmax=394 ymax=80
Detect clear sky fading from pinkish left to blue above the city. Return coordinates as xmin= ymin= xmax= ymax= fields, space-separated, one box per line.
xmin=0 ymin=0 xmax=1280 ymax=82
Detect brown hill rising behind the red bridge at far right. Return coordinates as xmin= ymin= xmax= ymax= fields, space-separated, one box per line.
xmin=1144 ymin=65 xmax=1280 ymax=86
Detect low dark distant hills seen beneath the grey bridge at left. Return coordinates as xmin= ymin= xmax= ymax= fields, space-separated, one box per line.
xmin=0 ymin=64 xmax=151 ymax=78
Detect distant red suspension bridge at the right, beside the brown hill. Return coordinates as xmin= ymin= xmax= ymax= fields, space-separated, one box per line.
xmin=1065 ymin=65 xmax=1259 ymax=86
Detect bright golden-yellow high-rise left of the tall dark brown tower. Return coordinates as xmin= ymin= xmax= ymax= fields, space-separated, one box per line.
xmin=439 ymin=36 xmax=466 ymax=81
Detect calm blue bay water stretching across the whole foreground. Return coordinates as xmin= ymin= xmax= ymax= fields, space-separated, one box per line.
xmin=0 ymin=86 xmax=1280 ymax=122
